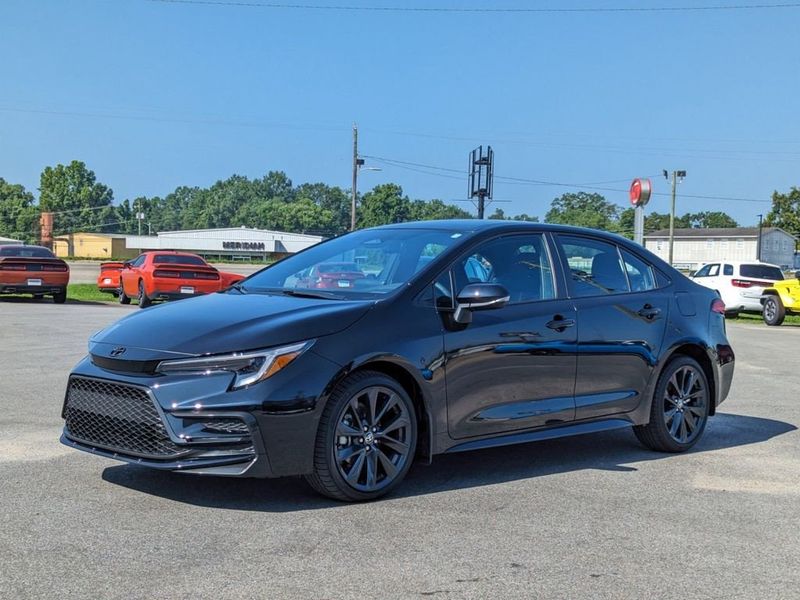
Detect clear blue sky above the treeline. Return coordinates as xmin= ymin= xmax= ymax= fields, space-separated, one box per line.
xmin=0 ymin=0 xmax=800 ymax=225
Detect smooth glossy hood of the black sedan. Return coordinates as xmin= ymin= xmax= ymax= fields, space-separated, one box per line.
xmin=89 ymin=293 xmax=373 ymax=360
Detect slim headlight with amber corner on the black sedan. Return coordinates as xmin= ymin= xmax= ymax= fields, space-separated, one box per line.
xmin=156 ymin=342 xmax=311 ymax=390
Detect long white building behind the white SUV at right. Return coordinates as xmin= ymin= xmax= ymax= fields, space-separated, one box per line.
xmin=644 ymin=227 xmax=797 ymax=270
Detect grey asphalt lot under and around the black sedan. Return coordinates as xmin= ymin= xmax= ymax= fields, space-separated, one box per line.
xmin=0 ymin=301 xmax=800 ymax=599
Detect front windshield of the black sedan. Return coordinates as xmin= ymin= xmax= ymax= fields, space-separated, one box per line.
xmin=241 ymin=228 xmax=464 ymax=299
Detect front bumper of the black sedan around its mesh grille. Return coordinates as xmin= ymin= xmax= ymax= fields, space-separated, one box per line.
xmin=61 ymin=351 xmax=339 ymax=477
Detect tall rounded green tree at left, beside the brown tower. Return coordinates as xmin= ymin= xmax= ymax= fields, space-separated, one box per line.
xmin=39 ymin=160 xmax=114 ymax=235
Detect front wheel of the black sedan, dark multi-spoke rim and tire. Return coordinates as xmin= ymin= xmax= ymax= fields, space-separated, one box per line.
xmin=305 ymin=371 xmax=417 ymax=502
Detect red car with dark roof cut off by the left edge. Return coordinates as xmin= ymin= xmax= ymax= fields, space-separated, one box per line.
xmin=0 ymin=246 xmax=69 ymax=304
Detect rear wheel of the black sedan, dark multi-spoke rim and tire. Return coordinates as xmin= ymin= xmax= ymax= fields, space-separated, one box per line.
xmin=633 ymin=356 xmax=712 ymax=452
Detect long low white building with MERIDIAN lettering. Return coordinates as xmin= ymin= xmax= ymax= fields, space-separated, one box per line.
xmin=125 ymin=227 xmax=324 ymax=258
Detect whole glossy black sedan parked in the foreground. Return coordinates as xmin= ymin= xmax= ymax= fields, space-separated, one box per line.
xmin=61 ymin=220 xmax=734 ymax=500
